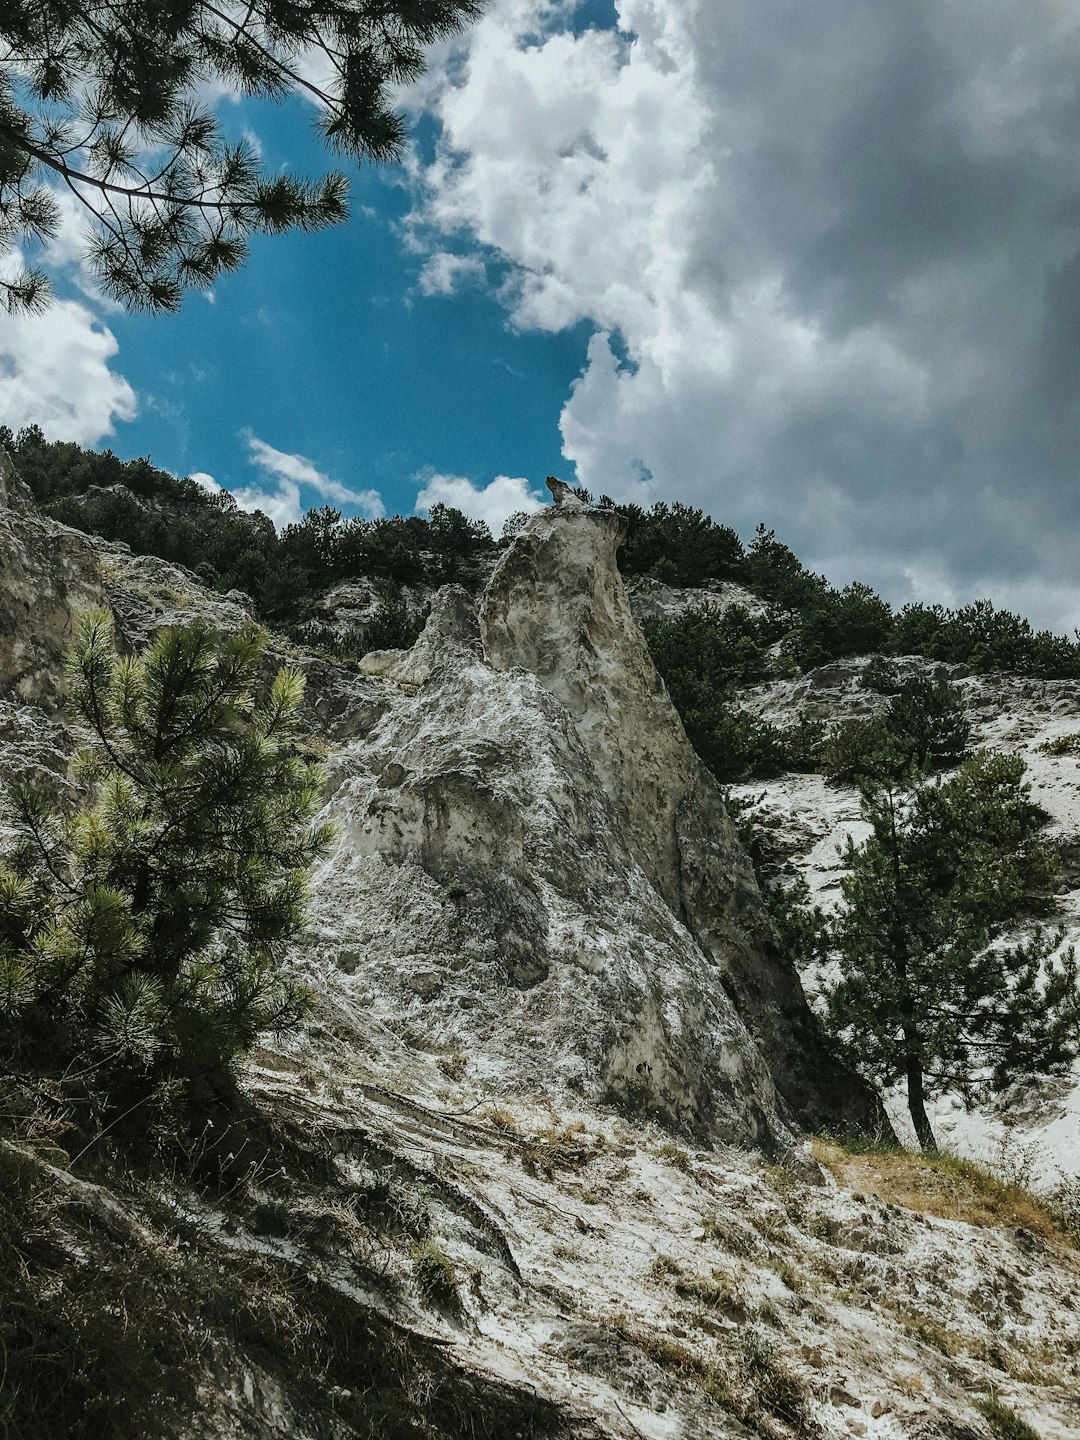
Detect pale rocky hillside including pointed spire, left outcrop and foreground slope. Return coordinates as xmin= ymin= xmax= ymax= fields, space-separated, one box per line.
xmin=0 ymin=455 xmax=1080 ymax=1440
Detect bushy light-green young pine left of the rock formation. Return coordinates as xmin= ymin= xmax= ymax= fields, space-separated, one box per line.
xmin=0 ymin=611 xmax=330 ymax=1076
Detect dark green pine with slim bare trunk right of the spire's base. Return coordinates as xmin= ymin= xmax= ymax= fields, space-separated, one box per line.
xmin=819 ymin=752 xmax=1080 ymax=1149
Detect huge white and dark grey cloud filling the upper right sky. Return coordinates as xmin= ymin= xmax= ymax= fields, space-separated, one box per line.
xmin=413 ymin=0 xmax=1080 ymax=624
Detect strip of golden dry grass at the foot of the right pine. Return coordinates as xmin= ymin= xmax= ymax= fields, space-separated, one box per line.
xmin=814 ymin=1139 xmax=1080 ymax=1248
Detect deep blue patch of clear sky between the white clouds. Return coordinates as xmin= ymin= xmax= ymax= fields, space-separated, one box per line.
xmin=68 ymin=101 xmax=588 ymax=524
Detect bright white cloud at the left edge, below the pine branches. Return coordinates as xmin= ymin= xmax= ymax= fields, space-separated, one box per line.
xmin=0 ymin=277 xmax=137 ymax=445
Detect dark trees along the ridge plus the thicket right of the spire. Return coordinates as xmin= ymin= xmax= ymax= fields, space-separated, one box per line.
xmin=10 ymin=426 xmax=1080 ymax=800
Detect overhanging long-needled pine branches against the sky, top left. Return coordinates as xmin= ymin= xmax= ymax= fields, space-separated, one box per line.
xmin=0 ymin=0 xmax=480 ymax=311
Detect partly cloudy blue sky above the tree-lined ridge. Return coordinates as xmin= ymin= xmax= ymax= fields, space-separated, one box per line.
xmin=0 ymin=0 xmax=1080 ymax=631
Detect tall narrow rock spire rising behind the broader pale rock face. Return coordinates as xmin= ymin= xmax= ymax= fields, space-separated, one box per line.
xmin=481 ymin=507 xmax=874 ymax=1126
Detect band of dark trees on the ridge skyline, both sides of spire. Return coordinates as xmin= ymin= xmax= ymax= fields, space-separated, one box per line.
xmin=8 ymin=425 xmax=1080 ymax=680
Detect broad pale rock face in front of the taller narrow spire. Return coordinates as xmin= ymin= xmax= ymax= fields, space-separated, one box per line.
xmin=314 ymin=592 xmax=785 ymax=1148
